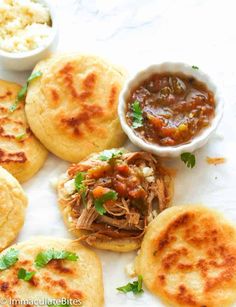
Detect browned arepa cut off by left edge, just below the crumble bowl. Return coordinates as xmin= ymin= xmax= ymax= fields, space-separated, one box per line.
xmin=0 ymin=80 xmax=47 ymax=182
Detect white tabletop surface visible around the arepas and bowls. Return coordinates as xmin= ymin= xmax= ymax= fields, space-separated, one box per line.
xmin=0 ymin=0 xmax=236 ymax=307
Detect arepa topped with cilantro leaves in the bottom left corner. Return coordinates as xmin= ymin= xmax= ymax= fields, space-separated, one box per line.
xmin=0 ymin=237 xmax=104 ymax=307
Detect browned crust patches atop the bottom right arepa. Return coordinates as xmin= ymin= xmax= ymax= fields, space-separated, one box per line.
xmin=149 ymin=212 xmax=236 ymax=307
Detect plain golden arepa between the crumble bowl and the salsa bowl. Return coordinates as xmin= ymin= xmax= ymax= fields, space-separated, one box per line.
xmin=26 ymin=54 xmax=125 ymax=162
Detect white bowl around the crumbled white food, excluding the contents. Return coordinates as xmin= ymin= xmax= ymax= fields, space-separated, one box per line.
xmin=0 ymin=0 xmax=58 ymax=71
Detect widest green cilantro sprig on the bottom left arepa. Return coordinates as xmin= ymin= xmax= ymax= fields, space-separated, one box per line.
xmin=35 ymin=249 xmax=79 ymax=268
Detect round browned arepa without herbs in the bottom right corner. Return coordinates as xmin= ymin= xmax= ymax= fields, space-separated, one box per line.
xmin=135 ymin=205 xmax=236 ymax=307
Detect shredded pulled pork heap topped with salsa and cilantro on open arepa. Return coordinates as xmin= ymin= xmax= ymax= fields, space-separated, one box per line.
xmin=65 ymin=150 xmax=171 ymax=240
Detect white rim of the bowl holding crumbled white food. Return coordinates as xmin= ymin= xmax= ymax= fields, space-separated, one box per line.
xmin=0 ymin=0 xmax=58 ymax=60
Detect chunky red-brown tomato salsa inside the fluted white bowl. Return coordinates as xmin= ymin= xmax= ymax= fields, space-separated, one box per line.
xmin=126 ymin=73 xmax=215 ymax=146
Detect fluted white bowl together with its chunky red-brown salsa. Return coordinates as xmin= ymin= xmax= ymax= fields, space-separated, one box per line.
xmin=118 ymin=62 xmax=223 ymax=157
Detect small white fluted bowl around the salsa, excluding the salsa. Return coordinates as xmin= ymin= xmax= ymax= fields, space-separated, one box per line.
xmin=118 ymin=62 xmax=224 ymax=157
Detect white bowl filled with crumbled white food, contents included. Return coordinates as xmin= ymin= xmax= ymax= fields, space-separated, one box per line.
xmin=0 ymin=0 xmax=58 ymax=71
